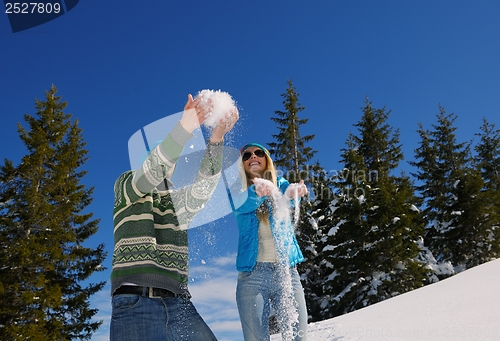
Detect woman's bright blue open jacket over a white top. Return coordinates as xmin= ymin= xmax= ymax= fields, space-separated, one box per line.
xmin=233 ymin=177 xmax=304 ymax=272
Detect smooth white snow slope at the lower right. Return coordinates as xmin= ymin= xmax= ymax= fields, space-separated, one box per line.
xmin=271 ymin=259 xmax=500 ymax=341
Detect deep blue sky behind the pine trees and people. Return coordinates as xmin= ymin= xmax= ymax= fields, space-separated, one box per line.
xmin=0 ymin=0 xmax=500 ymax=341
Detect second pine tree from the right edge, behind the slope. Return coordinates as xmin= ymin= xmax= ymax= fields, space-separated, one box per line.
xmin=411 ymin=106 xmax=487 ymax=270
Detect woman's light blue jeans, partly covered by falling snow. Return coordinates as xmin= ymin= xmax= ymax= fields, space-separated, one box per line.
xmin=236 ymin=262 xmax=307 ymax=341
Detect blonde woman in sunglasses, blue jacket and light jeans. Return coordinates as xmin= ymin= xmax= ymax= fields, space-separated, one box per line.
xmin=233 ymin=143 xmax=307 ymax=341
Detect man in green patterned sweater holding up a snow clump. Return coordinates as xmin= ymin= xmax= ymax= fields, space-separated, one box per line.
xmin=110 ymin=95 xmax=238 ymax=341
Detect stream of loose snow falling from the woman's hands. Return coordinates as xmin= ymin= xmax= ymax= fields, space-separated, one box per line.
xmin=253 ymin=178 xmax=300 ymax=341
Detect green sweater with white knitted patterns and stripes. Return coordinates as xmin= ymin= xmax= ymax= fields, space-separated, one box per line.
xmin=111 ymin=123 xmax=222 ymax=294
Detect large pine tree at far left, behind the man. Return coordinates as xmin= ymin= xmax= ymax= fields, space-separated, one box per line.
xmin=0 ymin=86 xmax=105 ymax=341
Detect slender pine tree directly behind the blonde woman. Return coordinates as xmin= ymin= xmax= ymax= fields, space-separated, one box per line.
xmin=269 ymin=80 xmax=332 ymax=321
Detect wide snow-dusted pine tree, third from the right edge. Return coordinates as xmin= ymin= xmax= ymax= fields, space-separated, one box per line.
xmin=321 ymin=99 xmax=429 ymax=318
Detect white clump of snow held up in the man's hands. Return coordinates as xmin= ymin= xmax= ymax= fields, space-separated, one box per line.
xmin=196 ymin=90 xmax=236 ymax=128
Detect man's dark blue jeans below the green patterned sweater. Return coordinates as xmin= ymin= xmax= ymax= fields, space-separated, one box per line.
xmin=110 ymin=294 xmax=217 ymax=341
